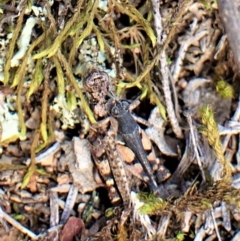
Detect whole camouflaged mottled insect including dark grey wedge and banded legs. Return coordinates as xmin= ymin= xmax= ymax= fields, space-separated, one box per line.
xmin=84 ymin=69 xmax=170 ymax=206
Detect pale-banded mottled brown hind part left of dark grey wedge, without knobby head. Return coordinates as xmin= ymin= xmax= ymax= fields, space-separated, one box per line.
xmin=88 ymin=118 xmax=130 ymax=206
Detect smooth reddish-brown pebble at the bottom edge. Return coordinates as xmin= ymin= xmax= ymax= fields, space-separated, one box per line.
xmin=60 ymin=217 xmax=84 ymax=241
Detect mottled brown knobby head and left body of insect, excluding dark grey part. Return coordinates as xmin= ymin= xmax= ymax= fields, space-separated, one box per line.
xmin=83 ymin=68 xmax=127 ymax=205
